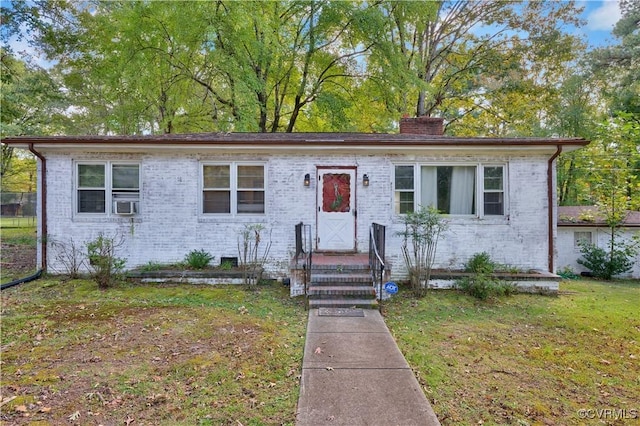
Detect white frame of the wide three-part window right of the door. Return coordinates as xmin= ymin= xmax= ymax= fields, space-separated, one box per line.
xmin=391 ymin=162 xmax=509 ymax=219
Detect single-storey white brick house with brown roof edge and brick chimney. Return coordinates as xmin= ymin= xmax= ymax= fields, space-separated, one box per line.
xmin=2 ymin=118 xmax=588 ymax=292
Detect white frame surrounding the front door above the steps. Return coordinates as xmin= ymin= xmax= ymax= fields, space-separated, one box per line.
xmin=315 ymin=166 xmax=358 ymax=252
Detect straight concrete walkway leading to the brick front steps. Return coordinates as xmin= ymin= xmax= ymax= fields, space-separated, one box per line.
xmin=296 ymin=309 xmax=440 ymax=426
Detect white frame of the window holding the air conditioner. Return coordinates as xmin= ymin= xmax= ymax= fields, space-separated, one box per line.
xmin=73 ymin=160 xmax=142 ymax=217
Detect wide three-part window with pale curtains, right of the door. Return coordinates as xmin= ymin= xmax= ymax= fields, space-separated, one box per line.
xmin=394 ymin=164 xmax=505 ymax=216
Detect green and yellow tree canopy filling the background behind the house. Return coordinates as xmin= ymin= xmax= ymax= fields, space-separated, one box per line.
xmin=0 ymin=0 xmax=640 ymax=208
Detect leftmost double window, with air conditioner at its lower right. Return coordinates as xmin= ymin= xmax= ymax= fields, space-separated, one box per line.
xmin=76 ymin=162 xmax=140 ymax=214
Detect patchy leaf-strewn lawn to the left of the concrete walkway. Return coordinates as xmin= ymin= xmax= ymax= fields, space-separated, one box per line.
xmin=0 ymin=278 xmax=306 ymax=425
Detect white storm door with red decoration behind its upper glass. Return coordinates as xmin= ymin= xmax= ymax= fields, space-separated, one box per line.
xmin=317 ymin=169 xmax=356 ymax=250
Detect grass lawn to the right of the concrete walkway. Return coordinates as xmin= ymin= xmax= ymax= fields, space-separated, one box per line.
xmin=385 ymin=280 xmax=640 ymax=425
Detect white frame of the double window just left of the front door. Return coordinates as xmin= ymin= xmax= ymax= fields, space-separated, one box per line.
xmin=199 ymin=161 xmax=267 ymax=217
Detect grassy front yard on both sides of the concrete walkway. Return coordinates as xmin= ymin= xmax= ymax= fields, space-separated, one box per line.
xmin=0 ymin=228 xmax=640 ymax=426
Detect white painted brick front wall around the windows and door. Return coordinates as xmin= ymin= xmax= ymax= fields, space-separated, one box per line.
xmin=45 ymin=153 xmax=560 ymax=279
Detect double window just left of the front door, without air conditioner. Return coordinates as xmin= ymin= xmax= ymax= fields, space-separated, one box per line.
xmin=202 ymin=163 xmax=265 ymax=214
